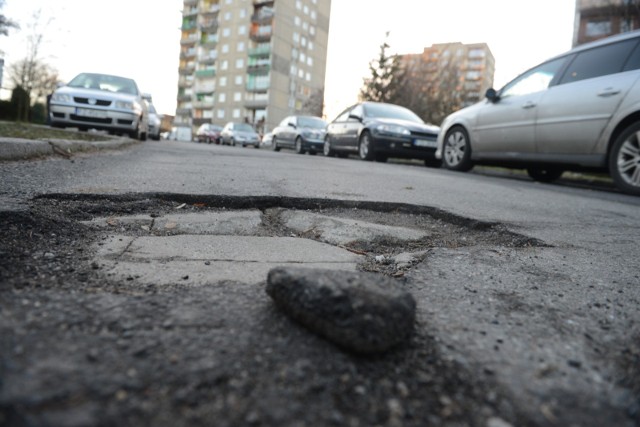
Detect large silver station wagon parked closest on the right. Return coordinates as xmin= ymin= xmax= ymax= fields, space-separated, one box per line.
xmin=437 ymin=31 xmax=640 ymax=195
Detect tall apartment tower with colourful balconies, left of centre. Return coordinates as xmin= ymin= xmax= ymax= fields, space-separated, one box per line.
xmin=174 ymin=0 xmax=331 ymax=137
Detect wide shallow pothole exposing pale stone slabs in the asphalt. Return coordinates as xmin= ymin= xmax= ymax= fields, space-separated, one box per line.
xmin=35 ymin=195 xmax=541 ymax=286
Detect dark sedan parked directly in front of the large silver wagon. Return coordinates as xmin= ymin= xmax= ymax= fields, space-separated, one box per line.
xmin=324 ymin=102 xmax=440 ymax=166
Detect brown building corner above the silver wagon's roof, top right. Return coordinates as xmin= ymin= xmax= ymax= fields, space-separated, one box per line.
xmin=573 ymin=0 xmax=640 ymax=46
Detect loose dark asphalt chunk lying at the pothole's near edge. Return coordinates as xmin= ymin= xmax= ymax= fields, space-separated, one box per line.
xmin=266 ymin=267 xmax=416 ymax=354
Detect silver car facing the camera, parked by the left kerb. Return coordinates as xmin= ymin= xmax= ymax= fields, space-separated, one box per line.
xmin=49 ymin=73 xmax=150 ymax=140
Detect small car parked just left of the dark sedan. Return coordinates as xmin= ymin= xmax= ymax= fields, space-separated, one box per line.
xmin=271 ymin=116 xmax=327 ymax=154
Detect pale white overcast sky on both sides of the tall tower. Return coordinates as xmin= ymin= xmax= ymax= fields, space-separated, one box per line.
xmin=0 ymin=0 xmax=575 ymax=119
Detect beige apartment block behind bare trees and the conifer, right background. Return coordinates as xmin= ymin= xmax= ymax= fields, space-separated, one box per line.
xmin=402 ymin=42 xmax=495 ymax=114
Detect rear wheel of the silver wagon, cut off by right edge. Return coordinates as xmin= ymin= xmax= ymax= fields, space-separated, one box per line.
xmin=609 ymin=122 xmax=640 ymax=196
